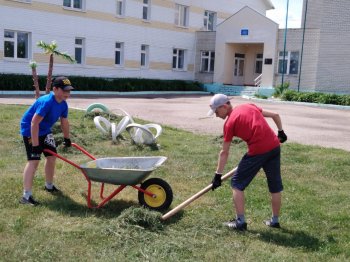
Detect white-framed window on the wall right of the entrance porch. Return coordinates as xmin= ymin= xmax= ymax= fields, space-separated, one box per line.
xmin=278 ymin=51 xmax=299 ymax=75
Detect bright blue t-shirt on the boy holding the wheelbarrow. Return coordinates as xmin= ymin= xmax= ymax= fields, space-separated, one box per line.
xmin=21 ymin=93 xmax=68 ymax=137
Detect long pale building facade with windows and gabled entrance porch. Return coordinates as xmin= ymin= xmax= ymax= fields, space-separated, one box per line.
xmin=0 ymin=0 xmax=350 ymax=93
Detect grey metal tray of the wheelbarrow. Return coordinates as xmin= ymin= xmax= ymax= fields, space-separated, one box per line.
xmin=80 ymin=156 xmax=167 ymax=185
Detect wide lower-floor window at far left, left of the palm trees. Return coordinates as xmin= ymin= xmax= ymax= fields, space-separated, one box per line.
xmin=4 ymin=30 xmax=29 ymax=59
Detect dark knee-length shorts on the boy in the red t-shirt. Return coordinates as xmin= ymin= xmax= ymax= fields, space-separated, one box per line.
xmin=231 ymin=146 xmax=283 ymax=193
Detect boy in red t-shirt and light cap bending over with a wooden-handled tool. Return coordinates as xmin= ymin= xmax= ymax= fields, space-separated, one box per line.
xmin=208 ymin=94 xmax=287 ymax=230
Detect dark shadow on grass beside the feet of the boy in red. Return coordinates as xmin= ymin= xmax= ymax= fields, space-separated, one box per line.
xmin=249 ymin=228 xmax=324 ymax=251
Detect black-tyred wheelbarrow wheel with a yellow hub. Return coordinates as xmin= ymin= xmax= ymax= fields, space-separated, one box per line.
xmin=138 ymin=178 xmax=173 ymax=211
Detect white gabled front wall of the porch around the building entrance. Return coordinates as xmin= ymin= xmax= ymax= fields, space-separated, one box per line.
xmin=214 ymin=7 xmax=278 ymax=87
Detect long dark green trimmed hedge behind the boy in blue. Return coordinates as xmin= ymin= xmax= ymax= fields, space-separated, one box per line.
xmin=0 ymin=74 xmax=203 ymax=92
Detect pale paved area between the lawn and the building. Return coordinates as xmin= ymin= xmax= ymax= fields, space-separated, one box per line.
xmin=0 ymin=94 xmax=350 ymax=151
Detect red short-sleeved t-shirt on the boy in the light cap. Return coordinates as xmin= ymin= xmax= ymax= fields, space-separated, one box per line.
xmin=224 ymin=104 xmax=280 ymax=155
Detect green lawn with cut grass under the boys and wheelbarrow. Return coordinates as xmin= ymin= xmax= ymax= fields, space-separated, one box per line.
xmin=0 ymin=105 xmax=350 ymax=261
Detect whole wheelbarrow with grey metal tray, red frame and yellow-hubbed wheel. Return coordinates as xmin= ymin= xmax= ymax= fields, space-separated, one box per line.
xmin=44 ymin=143 xmax=173 ymax=211
